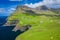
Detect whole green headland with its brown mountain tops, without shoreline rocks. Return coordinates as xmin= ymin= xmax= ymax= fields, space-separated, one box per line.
xmin=7 ymin=5 xmax=60 ymax=40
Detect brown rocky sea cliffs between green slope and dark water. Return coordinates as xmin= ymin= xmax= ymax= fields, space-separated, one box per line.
xmin=3 ymin=20 xmax=31 ymax=32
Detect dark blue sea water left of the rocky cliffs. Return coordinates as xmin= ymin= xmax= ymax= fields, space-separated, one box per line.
xmin=0 ymin=16 xmax=22 ymax=40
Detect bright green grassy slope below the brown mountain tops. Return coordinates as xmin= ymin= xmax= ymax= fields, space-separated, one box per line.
xmin=8 ymin=5 xmax=60 ymax=40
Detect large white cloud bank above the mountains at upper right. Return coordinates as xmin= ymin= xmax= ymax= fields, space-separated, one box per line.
xmin=25 ymin=0 xmax=60 ymax=8
